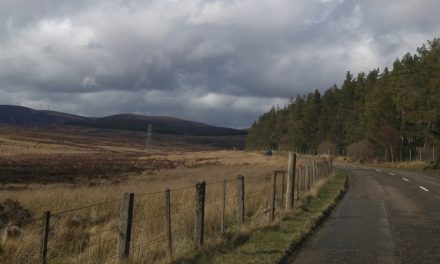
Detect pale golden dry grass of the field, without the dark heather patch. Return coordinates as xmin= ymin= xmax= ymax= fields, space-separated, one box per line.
xmin=0 ymin=127 xmax=330 ymax=263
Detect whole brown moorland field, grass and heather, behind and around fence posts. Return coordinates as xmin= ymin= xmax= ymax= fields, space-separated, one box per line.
xmin=0 ymin=128 xmax=312 ymax=263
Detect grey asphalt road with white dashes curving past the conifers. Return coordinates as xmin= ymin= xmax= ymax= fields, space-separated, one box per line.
xmin=292 ymin=164 xmax=440 ymax=264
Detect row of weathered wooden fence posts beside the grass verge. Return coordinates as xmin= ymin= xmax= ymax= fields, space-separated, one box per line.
xmin=33 ymin=151 xmax=340 ymax=264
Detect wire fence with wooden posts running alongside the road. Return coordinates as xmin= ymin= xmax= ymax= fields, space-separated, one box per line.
xmin=0 ymin=155 xmax=333 ymax=264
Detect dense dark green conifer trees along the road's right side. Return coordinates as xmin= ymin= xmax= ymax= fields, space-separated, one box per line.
xmin=246 ymin=38 xmax=440 ymax=160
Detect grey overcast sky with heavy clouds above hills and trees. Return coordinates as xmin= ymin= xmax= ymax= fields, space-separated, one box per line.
xmin=0 ymin=0 xmax=440 ymax=128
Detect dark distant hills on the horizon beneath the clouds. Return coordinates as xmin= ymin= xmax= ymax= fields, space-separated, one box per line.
xmin=0 ymin=105 xmax=246 ymax=136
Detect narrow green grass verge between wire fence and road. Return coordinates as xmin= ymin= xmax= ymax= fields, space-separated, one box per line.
xmin=177 ymin=171 xmax=346 ymax=263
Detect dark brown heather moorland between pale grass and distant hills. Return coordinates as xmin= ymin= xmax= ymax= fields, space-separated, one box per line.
xmin=0 ymin=127 xmax=243 ymax=184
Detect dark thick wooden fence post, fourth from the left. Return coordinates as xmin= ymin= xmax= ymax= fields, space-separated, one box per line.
xmin=194 ymin=182 xmax=206 ymax=247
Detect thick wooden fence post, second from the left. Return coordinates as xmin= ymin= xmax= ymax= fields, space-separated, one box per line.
xmin=118 ymin=193 xmax=134 ymax=260
